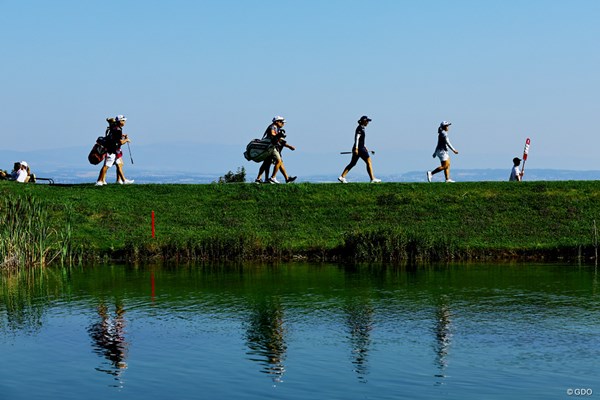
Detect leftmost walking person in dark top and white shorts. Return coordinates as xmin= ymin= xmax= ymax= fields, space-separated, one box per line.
xmin=96 ymin=115 xmax=133 ymax=186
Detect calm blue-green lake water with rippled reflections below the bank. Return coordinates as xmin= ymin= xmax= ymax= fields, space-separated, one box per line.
xmin=0 ymin=263 xmax=600 ymax=400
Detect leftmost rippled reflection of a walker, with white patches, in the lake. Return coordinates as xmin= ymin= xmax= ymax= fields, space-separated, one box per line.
xmin=88 ymin=300 xmax=128 ymax=387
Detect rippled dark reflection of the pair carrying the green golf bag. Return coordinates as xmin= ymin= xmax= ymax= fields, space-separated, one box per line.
xmin=246 ymin=296 xmax=287 ymax=384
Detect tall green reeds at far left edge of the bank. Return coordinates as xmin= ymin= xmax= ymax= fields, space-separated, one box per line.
xmin=0 ymin=194 xmax=74 ymax=269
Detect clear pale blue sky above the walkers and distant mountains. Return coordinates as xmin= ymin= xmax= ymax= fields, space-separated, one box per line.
xmin=0 ymin=0 xmax=600 ymax=176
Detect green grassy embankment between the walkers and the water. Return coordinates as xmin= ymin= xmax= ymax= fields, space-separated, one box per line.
xmin=0 ymin=181 xmax=600 ymax=268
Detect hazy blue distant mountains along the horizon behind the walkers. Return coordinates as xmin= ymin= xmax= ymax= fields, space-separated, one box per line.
xmin=0 ymin=143 xmax=600 ymax=184
